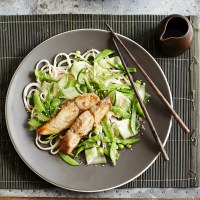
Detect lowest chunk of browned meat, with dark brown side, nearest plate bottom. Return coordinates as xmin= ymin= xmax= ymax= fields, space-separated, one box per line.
xmin=60 ymin=130 xmax=81 ymax=154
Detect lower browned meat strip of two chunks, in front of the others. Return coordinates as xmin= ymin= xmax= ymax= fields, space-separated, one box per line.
xmin=60 ymin=111 xmax=94 ymax=154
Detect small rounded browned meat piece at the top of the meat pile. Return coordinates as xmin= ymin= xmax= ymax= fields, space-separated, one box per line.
xmin=75 ymin=93 xmax=100 ymax=110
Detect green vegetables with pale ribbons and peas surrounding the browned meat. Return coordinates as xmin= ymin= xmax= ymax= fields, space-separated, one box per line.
xmin=23 ymin=49 xmax=148 ymax=165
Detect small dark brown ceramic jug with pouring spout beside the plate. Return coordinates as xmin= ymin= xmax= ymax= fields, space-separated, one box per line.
xmin=155 ymin=15 xmax=193 ymax=56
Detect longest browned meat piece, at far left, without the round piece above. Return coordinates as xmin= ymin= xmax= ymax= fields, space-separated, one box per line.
xmin=37 ymin=101 xmax=80 ymax=135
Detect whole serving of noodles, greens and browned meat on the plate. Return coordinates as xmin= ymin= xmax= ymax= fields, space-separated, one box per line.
xmin=23 ymin=49 xmax=149 ymax=166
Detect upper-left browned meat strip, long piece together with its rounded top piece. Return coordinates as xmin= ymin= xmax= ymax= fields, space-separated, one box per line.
xmin=37 ymin=93 xmax=100 ymax=135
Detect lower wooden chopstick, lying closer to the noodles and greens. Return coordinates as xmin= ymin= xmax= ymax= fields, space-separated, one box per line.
xmin=112 ymin=38 xmax=169 ymax=161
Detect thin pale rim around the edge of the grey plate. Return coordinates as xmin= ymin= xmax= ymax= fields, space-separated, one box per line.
xmin=5 ymin=28 xmax=173 ymax=193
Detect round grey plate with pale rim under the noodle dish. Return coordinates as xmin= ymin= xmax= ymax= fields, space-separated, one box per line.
xmin=6 ymin=29 xmax=172 ymax=192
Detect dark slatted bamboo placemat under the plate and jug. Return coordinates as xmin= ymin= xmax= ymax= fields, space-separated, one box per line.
xmin=0 ymin=15 xmax=198 ymax=189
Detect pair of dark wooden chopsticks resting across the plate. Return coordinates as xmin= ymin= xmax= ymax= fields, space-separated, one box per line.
xmin=105 ymin=23 xmax=190 ymax=161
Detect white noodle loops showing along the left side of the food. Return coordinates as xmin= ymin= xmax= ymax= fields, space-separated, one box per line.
xmin=23 ymin=49 xmax=99 ymax=154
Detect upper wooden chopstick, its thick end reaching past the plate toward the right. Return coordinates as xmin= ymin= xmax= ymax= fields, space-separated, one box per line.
xmin=105 ymin=23 xmax=190 ymax=133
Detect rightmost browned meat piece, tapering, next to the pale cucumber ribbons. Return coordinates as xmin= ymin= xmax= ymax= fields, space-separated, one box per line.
xmin=90 ymin=97 xmax=112 ymax=126
